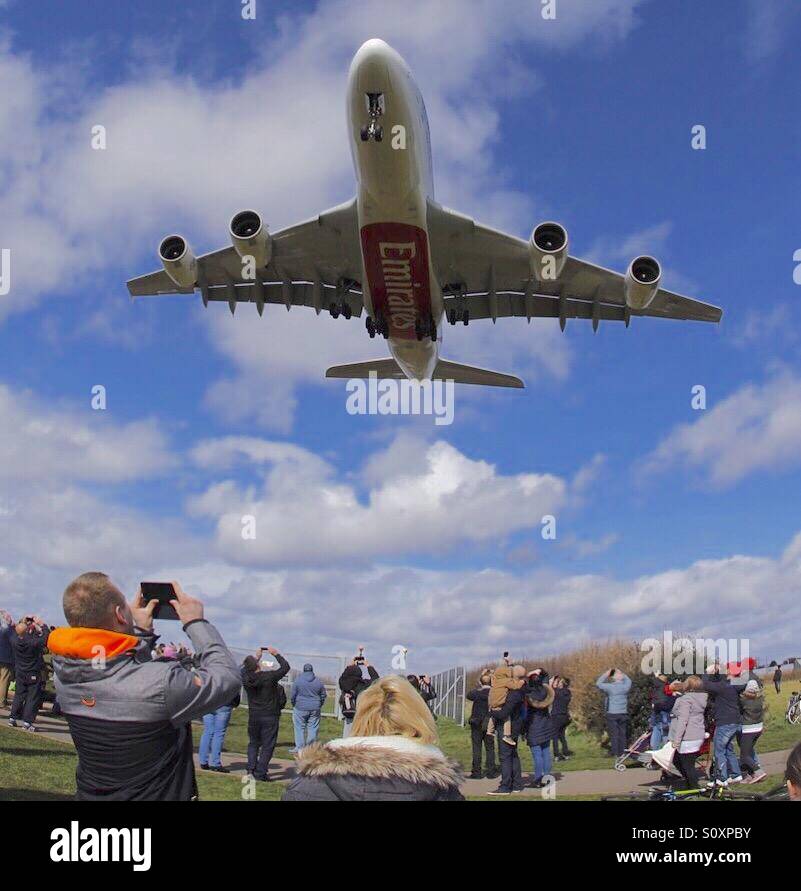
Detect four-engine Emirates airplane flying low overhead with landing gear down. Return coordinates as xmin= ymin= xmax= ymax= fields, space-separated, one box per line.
xmin=127 ymin=39 xmax=722 ymax=388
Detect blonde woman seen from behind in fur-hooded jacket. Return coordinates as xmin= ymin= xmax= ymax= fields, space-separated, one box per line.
xmin=283 ymin=675 xmax=463 ymax=801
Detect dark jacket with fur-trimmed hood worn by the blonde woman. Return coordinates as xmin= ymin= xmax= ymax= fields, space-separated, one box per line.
xmin=282 ymin=737 xmax=463 ymax=801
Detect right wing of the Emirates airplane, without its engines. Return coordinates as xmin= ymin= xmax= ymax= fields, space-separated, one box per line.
xmin=428 ymin=202 xmax=723 ymax=327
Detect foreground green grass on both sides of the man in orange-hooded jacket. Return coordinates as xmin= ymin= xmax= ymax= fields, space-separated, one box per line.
xmin=0 ymin=726 xmax=285 ymax=801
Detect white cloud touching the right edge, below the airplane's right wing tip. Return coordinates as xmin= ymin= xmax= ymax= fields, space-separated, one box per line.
xmin=643 ymin=372 xmax=801 ymax=486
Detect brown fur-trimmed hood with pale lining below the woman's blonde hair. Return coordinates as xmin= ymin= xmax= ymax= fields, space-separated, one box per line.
xmin=296 ymin=737 xmax=463 ymax=789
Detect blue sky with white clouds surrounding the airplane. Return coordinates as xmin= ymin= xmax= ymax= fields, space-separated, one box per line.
xmin=0 ymin=0 xmax=801 ymax=671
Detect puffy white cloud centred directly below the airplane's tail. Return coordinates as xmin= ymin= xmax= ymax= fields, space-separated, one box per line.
xmin=189 ymin=438 xmax=568 ymax=566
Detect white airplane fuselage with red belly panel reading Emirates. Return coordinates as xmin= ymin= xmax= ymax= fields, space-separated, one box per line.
xmin=348 ymin=40 xmax=444 ymax=380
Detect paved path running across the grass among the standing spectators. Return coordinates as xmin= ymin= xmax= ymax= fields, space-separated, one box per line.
xmin=0 ymin=708 xmax=790 ymax=798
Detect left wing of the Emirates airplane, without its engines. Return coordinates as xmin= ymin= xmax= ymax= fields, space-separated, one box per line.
xmin=128 ymin=198 xmax=363 ymax=316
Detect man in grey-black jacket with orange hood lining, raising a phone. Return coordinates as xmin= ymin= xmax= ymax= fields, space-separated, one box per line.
xmin=48 ymin=572 xmax=240 ymax=801
